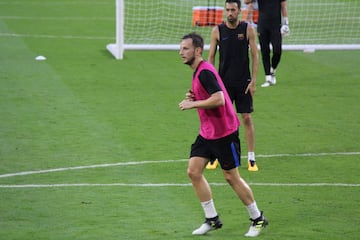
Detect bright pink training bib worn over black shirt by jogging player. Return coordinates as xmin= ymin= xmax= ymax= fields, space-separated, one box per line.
xmin=192 ymin=61 xmax=240 ymax=140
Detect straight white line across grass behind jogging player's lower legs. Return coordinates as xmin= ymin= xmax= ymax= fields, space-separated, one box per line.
xmin=0 ymin=183 xmax=360 ymax=188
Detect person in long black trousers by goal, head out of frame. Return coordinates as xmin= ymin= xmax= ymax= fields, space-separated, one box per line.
xmin=245 ymin=0 xmax=290 ymax=87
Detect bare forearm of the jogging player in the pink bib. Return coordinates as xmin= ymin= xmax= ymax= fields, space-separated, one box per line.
xmin=179 ymin=91 xmax=225 ymax=110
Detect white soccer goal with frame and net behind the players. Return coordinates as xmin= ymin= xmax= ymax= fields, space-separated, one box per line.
xmin=107 ymin=0 xmax=360 ymax=59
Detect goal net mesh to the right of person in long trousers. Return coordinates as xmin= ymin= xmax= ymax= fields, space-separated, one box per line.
xmin=285 ymin=0 xmax=360 ymax=44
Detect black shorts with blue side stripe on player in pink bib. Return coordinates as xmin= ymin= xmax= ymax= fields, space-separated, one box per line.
xmin=190 ymin=131 xmax=241 ymax=170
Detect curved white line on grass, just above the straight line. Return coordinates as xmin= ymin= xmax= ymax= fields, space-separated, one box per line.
xmin=0 ymin=152 xmax=360 ymax=178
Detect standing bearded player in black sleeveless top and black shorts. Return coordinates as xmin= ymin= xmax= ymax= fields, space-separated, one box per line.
xmin=208 ymin=0 xmax=259 ymax=171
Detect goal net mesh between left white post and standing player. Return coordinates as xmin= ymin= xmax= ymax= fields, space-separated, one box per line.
xmin=124 ymin=0 xmax=218 ymax=44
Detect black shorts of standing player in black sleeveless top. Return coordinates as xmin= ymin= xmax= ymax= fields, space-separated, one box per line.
xmin=225 ymin=84 xmax=254 ymax=113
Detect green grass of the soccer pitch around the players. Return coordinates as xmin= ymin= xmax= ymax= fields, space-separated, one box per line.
xmin=0 ymin=1 xmax=360 ymax=240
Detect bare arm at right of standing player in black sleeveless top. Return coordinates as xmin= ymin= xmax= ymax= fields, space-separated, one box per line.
xmin=245 ymin=24 xmax=259 ymax=96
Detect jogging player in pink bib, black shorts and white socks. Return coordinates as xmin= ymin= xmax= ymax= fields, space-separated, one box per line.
xmin=179 ymin=33 xmax=268 ymax=237
